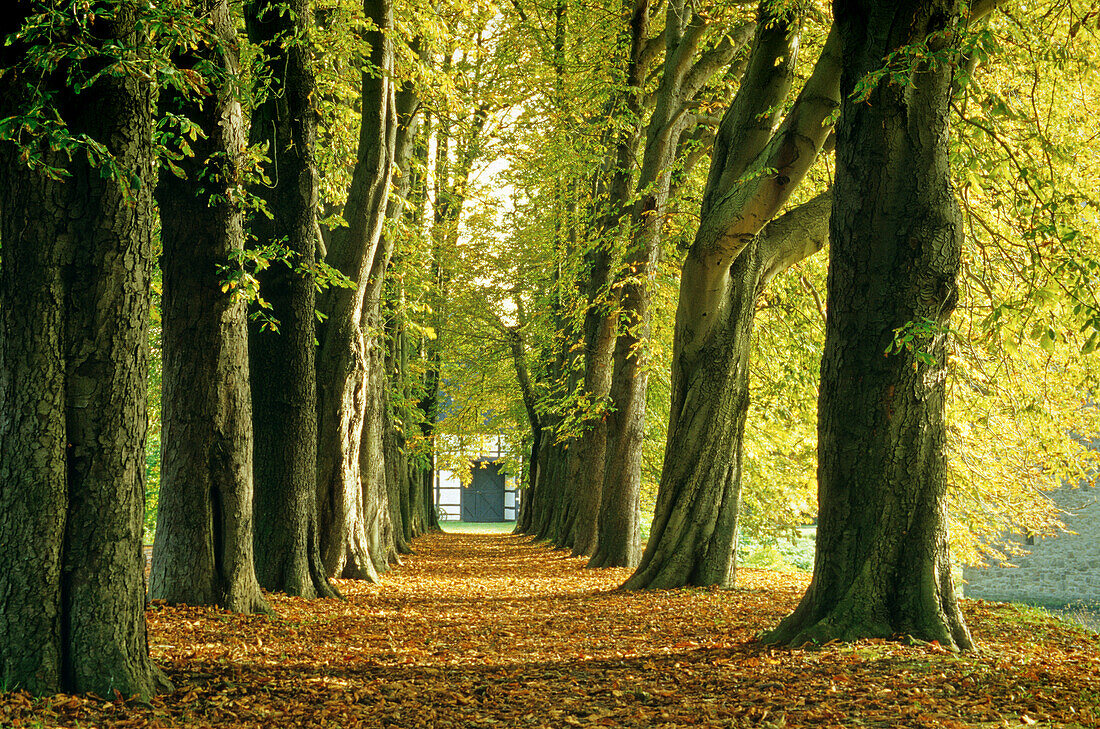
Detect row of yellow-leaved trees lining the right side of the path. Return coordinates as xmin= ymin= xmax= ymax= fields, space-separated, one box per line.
xmin=502 ymin=2 xmax=1096 ymax=647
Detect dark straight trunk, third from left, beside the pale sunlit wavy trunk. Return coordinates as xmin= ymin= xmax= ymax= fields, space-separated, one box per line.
xmin=245 ymin=0 xmax=339 ymax=597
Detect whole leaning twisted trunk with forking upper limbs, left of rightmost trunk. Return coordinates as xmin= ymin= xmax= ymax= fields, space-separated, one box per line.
xmin=625 ymin=5 xmax=839 ymax=588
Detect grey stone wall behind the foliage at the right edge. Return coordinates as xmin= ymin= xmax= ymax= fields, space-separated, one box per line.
xmin=963 ymin=485 xmax=1100 ymax=606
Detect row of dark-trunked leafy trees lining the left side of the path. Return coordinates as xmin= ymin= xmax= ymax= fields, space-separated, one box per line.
xmin=0 ymin=0 xmax=495 ymax=696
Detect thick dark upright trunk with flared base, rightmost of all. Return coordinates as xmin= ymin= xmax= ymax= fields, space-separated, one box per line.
xmin=766 ymin=0 xmax=972 ymax=649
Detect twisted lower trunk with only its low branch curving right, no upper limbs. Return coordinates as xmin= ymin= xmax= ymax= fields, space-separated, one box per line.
xmin=624 ymin=195 xmax=831 ymax=589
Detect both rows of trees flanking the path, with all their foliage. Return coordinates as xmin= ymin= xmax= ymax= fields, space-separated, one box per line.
xmin=0 ymin=0 xmax=1100 ymax=695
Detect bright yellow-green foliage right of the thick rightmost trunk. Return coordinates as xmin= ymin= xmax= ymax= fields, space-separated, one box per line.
xmin=948 ymin=3 xmax=1100 ymax=561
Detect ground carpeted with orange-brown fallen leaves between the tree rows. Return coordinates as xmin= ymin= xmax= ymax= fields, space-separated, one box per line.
xmin=0 ymin=533 xmax=1100 ymax=729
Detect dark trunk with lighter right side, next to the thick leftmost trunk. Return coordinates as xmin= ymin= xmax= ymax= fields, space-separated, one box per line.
xmin=150 ymin=0 xmax=270 ymax=612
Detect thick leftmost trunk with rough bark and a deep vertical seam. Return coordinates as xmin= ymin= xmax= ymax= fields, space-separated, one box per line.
xmin=0 ymin=2 xmax=171 ymax=697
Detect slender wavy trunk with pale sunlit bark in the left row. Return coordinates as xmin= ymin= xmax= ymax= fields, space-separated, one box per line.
xmin=317 ymin=0 xmax=397 ymax=581
